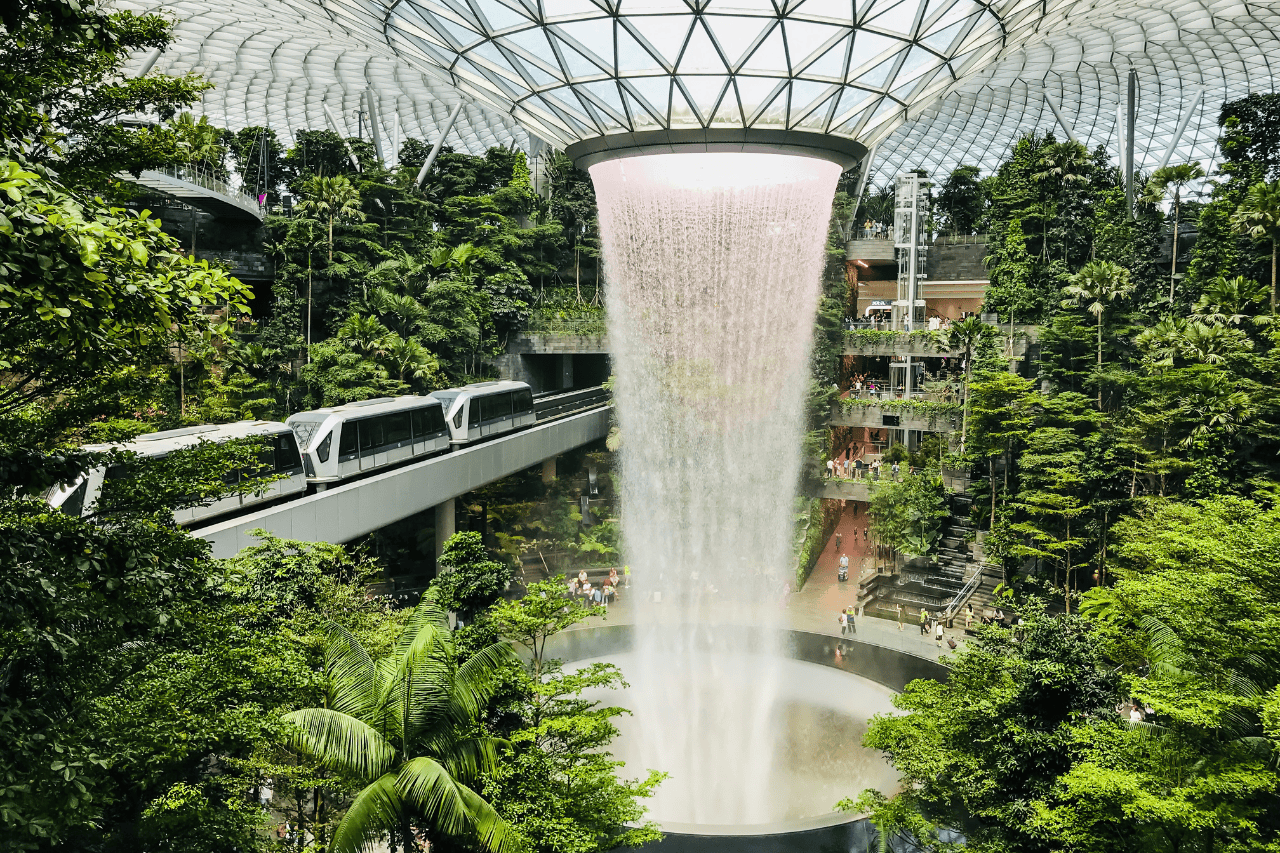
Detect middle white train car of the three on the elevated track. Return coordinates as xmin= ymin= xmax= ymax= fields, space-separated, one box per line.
xmin=284 ymin=394 xmax=449 ymax=491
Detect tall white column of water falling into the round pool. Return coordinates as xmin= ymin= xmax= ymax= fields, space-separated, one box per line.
xmin=590 ymin=154 xmax=841 ymax=824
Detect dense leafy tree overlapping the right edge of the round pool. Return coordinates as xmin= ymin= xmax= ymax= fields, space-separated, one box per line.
xmin=855 ymin=615 xmax=1125 ymax=852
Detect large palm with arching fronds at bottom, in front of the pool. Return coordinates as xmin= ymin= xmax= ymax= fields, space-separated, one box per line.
xmin=284 ymin=593 xmax=513 ymax=853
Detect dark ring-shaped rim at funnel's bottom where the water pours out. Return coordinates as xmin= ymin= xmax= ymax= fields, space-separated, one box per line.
xmin=564 ymin=128 xmax=867 ymax=170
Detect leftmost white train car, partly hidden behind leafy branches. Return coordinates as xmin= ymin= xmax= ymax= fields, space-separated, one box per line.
xmin=45 ymin=420 xmax=307 ymax=525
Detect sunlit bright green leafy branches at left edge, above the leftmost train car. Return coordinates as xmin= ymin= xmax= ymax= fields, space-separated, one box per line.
xmin=0 ymin=159 xmax=250 ymax=432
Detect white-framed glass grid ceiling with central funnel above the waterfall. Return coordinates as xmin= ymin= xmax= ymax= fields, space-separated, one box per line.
xmin=118 ymin=0 xmax=1280 ymax=178
